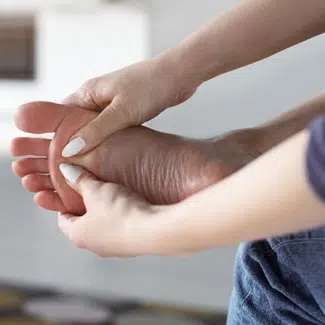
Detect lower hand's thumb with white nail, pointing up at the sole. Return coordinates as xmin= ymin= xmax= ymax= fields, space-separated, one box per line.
xmin=59 ymin=164 xmax=103 ymax=197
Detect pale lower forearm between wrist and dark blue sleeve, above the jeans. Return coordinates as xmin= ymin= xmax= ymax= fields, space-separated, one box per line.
xmin=149 ymin=131 xmax=325 ymax=255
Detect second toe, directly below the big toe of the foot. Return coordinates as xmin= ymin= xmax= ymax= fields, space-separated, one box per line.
xmin=10 ymin=138 xmax=51 ymax=157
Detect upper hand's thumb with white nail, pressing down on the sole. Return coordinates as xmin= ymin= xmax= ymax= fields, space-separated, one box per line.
xmin=62 ymin=100 xmax=132 ymax=158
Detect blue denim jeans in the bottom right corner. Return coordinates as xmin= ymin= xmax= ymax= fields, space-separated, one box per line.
xmin=227 ymin=228 xmax=325 ymax=325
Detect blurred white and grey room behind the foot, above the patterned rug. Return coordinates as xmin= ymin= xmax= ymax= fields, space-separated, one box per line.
xmin=0 ymin=0 xmax=325 ymax=324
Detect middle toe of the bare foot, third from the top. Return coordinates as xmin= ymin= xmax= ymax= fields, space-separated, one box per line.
xmin=12 ymin=158 xmax=49 ymax=177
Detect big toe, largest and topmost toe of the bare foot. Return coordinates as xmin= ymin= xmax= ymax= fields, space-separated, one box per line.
xmin=15 ymin=102 xmax=69 ymax=134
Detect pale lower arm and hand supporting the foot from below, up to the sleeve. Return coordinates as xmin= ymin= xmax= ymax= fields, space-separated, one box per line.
xmin=55 ymin=131 xmax=325 ymax=257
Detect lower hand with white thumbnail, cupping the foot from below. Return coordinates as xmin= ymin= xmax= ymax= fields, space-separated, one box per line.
xmin=58 ymin=164 xmax=163 ymax=257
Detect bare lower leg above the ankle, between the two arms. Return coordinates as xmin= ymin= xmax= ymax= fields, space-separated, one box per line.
xmin=254 ymin=92 xmax=325 ymax=153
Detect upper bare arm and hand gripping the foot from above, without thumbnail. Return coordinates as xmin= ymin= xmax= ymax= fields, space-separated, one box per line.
xmin=61 ymin=0 xmax=325 ymax=153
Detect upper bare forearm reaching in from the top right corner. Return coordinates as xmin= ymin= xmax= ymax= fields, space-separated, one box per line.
xmin=154 ymin=0 xmax=325 ymax=84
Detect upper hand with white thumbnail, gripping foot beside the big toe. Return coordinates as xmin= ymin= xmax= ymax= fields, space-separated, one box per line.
xmin=62 ymin=59 xmax=197 ymax=157
